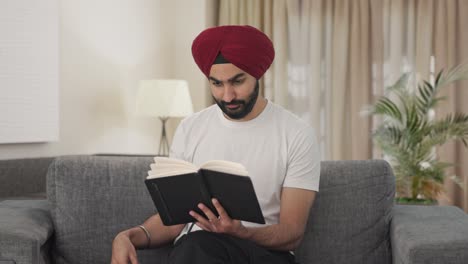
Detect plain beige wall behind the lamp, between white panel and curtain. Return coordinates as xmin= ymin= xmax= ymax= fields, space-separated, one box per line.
xmin=0 ymin=0 xmax=212 ymax=159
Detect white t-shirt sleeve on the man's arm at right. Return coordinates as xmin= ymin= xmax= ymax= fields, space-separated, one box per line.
xmin=283 ymin=126 xmax=320 ymax=191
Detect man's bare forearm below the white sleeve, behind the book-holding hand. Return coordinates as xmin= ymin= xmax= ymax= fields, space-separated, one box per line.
xmin=241 ymin=224 xmax=303 ymax=251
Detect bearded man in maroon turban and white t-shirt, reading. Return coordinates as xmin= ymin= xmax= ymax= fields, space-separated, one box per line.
xmin=112 ymin=26 xmax=320 ymax=263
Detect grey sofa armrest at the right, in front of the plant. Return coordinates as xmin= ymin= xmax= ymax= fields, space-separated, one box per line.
xmin=390 ymin=205 xmax=468 ymax=264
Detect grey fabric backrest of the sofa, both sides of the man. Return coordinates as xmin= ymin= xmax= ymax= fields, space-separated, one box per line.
xmin=47 ymin=156 xmax=395 ymax=264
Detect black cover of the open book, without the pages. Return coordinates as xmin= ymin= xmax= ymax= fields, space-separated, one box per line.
xmin=145 ymin=169 xmax=265 ymax=225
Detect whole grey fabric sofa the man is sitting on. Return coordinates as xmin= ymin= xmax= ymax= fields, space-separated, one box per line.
xmin=0 ymin=156 xmax=468 ymax=264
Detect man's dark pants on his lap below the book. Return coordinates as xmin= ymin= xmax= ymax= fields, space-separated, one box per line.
xmin=169 ymin=231 xmax=296 ymax=264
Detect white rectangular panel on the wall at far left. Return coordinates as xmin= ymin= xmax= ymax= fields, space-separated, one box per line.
xmin=0 ymin=0 xmax=59 ymax=143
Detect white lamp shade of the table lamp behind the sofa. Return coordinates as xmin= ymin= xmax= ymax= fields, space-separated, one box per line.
xmin=136 ymin=80 xmax=193 ymax=117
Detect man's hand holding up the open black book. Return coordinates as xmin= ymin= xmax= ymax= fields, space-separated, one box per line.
xmin=190 ymin=199 xmax=248 ymax=238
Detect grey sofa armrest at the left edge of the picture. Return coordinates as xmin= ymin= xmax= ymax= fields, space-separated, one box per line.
xmin=0 ymin=200 xmax=53 ymax=264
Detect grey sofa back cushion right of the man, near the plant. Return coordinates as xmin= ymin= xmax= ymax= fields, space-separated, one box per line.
xmin=296 ymin=160 xmax=395 ymax=264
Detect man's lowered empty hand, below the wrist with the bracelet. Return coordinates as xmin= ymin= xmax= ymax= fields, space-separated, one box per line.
xmin=111 ymin=232 xmax=138 ymax=264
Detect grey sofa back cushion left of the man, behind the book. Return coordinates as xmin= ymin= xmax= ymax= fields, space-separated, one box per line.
xmin=47 ymin=156 xmax=165 ymax=263
